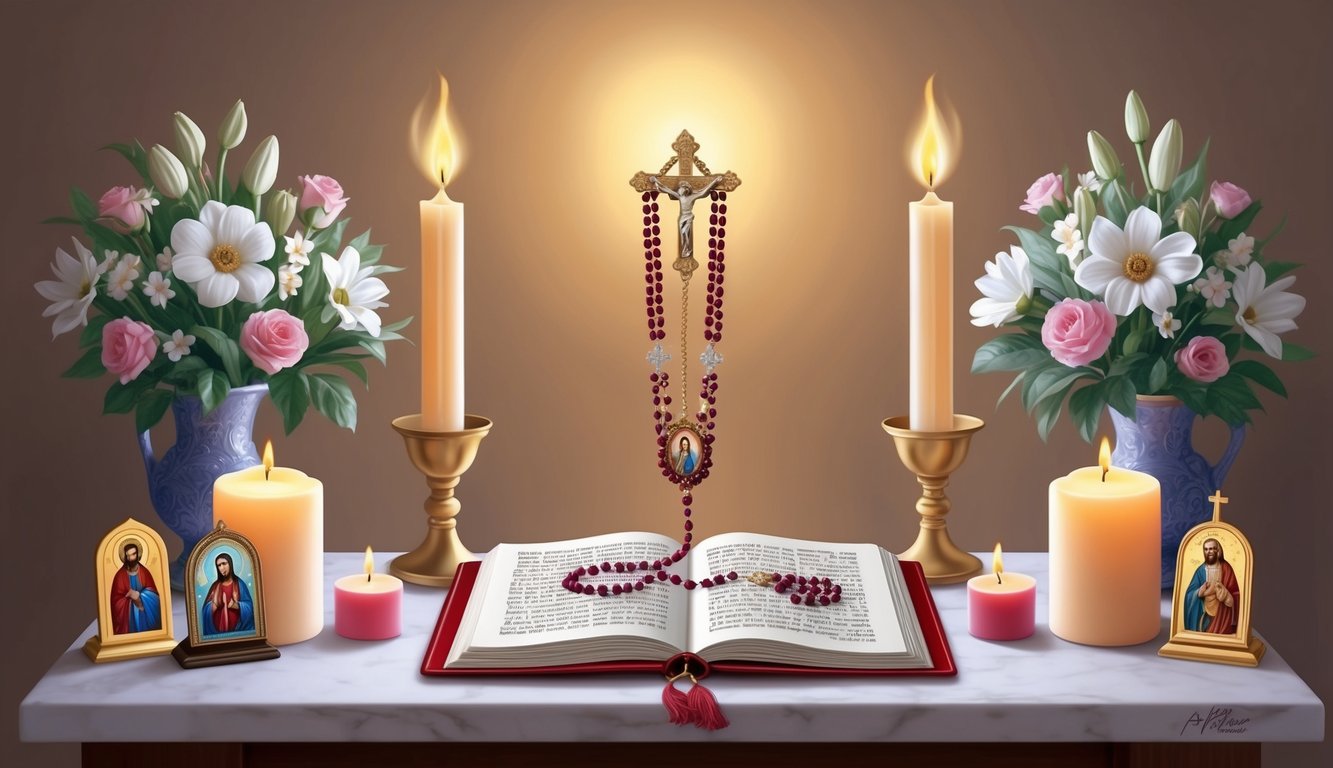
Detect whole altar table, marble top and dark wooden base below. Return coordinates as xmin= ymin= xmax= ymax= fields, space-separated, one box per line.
xmin=20 ymin=552 xmax=1324 ymax=768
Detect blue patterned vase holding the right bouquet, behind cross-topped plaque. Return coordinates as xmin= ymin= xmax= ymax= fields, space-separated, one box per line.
xmin=1110 ymin=395 xmax=1245 ymax=589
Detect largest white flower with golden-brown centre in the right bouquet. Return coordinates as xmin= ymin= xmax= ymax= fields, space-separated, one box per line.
xmin=1074 ymin=208 xmax=1204 ymax=316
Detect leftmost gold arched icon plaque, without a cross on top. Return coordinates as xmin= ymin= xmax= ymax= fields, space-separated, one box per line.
xmin=84 ymin=517 xmax=176 ymax=663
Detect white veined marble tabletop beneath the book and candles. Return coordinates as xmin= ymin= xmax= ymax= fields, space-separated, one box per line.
xmin=20 ymin=552 xmax=1324 ymax=741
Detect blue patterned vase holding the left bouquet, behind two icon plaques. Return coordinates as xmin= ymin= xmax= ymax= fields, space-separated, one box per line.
xmin=139 ymin=384 xmax=268 ymax=589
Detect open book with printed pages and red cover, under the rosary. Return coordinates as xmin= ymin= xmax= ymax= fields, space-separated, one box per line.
xmin=423 ymin=533 xmax=953 ymax=675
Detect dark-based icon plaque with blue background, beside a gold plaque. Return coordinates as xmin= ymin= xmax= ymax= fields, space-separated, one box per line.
xmin=172 ymin=520 xmax=279 ymax=669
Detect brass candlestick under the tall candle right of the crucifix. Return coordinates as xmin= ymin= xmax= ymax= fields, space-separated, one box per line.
xmin=884 ymin=413 xmax=985 ymax=584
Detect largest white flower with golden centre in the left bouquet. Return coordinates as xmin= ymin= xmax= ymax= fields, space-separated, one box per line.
xmin=171 ymin=200 xmax=275 ymax=307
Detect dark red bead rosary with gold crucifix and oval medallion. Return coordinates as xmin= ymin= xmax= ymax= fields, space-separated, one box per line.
xmin=563 ymin=131 xmax=842 ymax=605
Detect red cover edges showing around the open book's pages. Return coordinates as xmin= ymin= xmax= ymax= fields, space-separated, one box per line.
xmin=421 ymin=560 xmax=958 ymax=677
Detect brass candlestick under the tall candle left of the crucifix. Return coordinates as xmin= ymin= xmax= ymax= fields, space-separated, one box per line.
xmin=389 ymin=413 xmax=491 ymax=587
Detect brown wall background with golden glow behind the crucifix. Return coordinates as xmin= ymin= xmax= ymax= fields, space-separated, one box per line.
xmin=0 ymin=1 xmax=1333 ymax=765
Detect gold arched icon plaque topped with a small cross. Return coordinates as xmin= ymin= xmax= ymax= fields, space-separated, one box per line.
xmin=1157 ymin=491 xmax=1265 ymax=667
